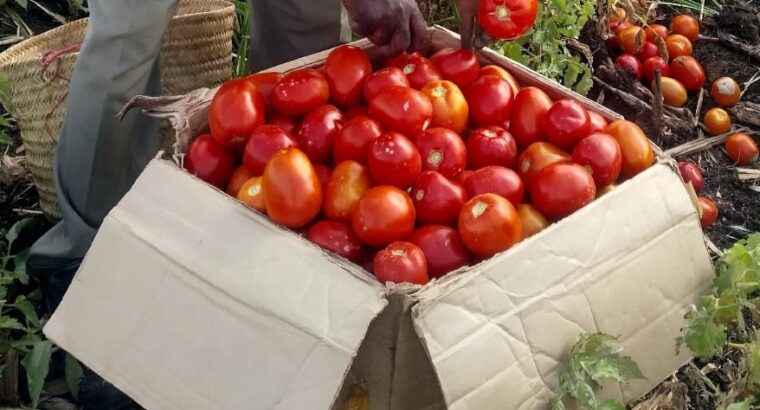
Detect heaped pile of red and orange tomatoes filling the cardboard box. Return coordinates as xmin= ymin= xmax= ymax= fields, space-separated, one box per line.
xmin=184 ymin=45 xmax=654 ymax=284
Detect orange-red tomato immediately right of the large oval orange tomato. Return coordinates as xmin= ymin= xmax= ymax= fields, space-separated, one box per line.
xmin=322 ymin=160 xmax=372 ymax=222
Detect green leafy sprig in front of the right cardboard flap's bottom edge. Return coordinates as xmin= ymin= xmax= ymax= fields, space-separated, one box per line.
xmin=550 ymin=333 xmax=644 ymax=410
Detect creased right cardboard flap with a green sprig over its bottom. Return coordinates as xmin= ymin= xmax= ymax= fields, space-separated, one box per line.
xmin=413 ymin=164 xmax=713 ymax=409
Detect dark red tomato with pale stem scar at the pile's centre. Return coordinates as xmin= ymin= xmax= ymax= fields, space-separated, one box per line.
xmin=414 ymin=127 xmax=467 ymax=178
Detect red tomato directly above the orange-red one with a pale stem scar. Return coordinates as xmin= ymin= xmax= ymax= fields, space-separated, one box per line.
xmin=464 ymin=165 xmax=525 ymax=206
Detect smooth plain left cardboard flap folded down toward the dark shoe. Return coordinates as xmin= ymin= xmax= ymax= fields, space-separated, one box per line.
xmin=45 ymin=160 xmax=387 ymax=410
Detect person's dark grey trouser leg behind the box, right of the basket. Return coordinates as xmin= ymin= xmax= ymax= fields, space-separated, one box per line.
xmin=248 ymin=0 xmax=351 ymax=72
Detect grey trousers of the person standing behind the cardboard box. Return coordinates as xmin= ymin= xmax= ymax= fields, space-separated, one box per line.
xmin=27 ymin=0 xmax=350 ymax=270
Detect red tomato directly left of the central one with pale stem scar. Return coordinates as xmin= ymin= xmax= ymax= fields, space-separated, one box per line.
xmin=369 ymin=131 xmax=422 ymax=189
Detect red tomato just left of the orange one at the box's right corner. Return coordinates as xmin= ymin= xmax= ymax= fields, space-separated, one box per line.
xmin=573 ymin=132 xmax=623 ymax=187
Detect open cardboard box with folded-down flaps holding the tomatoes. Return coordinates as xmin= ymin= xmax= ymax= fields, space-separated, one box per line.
xmin=44 ymin=27 xmax=713 ymax=410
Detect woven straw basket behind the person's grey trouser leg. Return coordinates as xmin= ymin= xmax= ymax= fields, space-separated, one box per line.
xmin=0 ymin=0 xmax=235 ymax=221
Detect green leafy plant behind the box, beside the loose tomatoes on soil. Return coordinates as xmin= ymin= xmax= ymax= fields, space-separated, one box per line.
xmin=496 ymin=0 xmax=596 ymax=95
